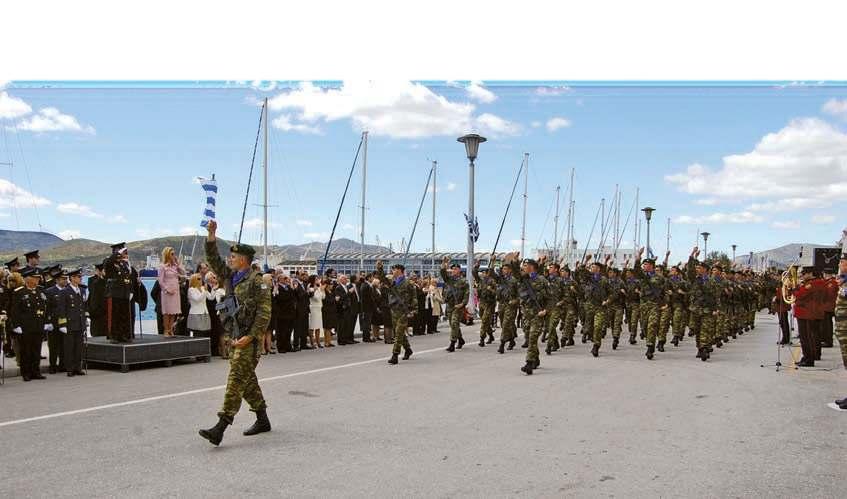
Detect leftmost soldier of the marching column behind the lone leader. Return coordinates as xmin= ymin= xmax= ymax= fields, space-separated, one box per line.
xmin=376 ymin=260 xmax=418 ymax=364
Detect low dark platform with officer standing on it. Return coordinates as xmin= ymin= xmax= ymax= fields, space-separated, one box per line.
xmin=84 ymin=334 xmax=211 ymax=373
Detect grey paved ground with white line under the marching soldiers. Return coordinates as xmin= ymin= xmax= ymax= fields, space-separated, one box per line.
xmin=0 ymin=316 xmax=847 ymax=498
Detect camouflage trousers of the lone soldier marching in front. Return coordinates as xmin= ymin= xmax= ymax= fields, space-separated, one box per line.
xmin=218 ymin=341 xmax=267 ymax=421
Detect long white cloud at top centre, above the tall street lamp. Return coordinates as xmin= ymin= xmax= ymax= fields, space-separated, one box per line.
xmin=270 ymin=81 xmax=520 ymax=139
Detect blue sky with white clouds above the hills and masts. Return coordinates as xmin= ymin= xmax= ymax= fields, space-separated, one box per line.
xmin=0 ymin=81 xmax=847 ymax=260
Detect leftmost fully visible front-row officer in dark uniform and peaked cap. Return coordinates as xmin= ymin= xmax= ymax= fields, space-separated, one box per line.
xmin=9 ymin=268 xmax=47 ymax=381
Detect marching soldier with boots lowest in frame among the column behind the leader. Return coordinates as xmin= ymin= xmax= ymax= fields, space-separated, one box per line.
xmin=503 ymin=253 xmax=550 ymax=375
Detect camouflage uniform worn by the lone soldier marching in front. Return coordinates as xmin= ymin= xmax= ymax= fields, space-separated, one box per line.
xmin=206 ymin=241 xmax=271 ymax=423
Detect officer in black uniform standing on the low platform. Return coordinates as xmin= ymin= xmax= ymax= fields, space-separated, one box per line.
xmin=103 ymin=243 xmax=137 ymax=343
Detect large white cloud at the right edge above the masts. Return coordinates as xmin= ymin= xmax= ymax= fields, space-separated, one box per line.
xmin=665 ymin=118 xmax=847 ymax=211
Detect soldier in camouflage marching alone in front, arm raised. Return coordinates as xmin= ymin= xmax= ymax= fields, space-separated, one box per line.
xmin=200 ymin=220 xmax=271 ymax=445
